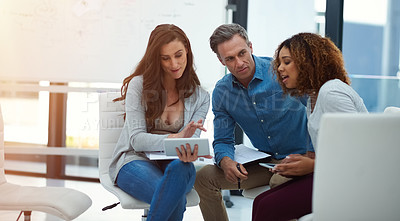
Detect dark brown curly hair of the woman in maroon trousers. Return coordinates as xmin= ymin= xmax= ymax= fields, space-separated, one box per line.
xmin=273 ymin=33 xmax=350 ymax=96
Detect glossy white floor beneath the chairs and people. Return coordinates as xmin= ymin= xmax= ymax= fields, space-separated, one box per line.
xmin=0 ymin=175 xmax=252 ymax=221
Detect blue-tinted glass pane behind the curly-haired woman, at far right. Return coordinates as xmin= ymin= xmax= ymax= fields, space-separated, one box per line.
xmin=343 ymin=0 xmax=400 ymax=112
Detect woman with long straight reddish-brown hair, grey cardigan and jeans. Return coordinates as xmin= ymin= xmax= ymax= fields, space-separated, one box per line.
xmin=110 ymin=24 xmax=210 ymax=221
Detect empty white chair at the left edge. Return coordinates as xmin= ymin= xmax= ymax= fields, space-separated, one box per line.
xmin=0 ymin=107 xmax=92 ymax=221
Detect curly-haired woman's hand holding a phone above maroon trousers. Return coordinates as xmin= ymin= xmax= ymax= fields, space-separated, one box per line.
xmin=271 ymin=154 xmax=314 ymax=177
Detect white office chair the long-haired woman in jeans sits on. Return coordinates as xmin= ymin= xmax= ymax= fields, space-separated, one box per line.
xmin=99 ymin=92 xmax=200 ymax=221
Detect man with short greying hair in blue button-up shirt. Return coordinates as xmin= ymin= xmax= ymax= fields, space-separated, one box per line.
xmin=195 ymin=24 xmax=313 ymax=221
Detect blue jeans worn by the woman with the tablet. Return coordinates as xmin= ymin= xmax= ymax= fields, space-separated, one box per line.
xmin=117 ymin=160 xmax=196 ymax=221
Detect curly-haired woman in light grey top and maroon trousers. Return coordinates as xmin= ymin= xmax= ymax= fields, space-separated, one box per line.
xmin=252 ymin=33 xmax=367 ymax=221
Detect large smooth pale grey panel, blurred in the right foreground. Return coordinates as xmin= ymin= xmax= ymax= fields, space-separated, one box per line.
xmin=313 ymin=113 xmax=400 ymax=221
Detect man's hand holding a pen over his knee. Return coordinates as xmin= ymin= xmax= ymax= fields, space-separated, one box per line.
xmin=220 ymin=157 xmax=248 ymax=183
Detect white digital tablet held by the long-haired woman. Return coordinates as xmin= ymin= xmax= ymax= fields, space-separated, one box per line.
xmin=164 ymin=138 xmax=210 ymax=156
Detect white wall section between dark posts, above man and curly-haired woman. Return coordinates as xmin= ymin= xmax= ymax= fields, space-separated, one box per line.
xmin=247 ymin=0 xmax=316 ymax=57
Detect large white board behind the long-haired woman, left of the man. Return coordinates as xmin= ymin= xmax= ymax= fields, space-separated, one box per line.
xmin=0 ymin=0 xmax=227 ymax=90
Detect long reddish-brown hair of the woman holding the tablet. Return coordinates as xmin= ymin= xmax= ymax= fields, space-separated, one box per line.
xmin=114 ymin=24 xmax=200 ymax=128
